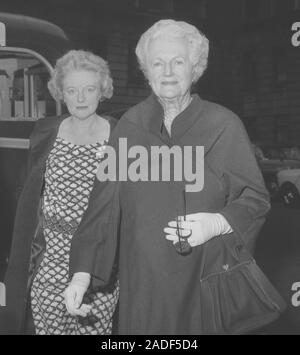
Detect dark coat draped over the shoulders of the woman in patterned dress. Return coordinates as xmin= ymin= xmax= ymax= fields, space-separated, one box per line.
xmin=0 ymin=116 xmax=117 ymax=334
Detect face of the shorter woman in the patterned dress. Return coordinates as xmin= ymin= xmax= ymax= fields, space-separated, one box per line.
xmin=63 ymin=70 xmax=101 ymax=119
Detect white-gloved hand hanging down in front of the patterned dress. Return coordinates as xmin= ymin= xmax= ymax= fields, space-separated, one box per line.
xmin=64 ymin=272 xmax=91 ymax=317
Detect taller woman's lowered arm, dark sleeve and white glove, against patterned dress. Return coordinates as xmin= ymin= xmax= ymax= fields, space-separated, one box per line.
xmin=65 ymin=121 xmax=121 ymax=316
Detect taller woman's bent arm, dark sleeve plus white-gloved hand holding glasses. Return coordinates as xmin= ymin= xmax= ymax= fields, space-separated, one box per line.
xmin=164 ymin=117 xmax=270 ymax=250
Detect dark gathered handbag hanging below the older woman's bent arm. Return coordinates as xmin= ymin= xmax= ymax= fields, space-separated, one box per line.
xmin=200 ymin=233 xmax=286 ymax=334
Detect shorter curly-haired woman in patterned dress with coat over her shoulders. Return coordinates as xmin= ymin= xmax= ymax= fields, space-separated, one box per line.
xmin=5 ymin=50 xmax=118 ymax=334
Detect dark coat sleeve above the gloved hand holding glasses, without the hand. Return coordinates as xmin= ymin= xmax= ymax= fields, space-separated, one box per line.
xmin=217 ymin=117 xmax=270 ymax=250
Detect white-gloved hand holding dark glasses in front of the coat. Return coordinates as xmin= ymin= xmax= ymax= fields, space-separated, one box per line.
xmin=164 ymin=212 xmax=232 ymax=247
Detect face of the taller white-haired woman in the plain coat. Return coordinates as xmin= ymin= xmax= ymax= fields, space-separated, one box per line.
xmin=147 ymin=36 xmax=193 ymax=100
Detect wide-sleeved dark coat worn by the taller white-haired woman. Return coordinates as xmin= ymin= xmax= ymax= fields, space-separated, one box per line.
xmin=70 ymin=95 xmax=270 ymax=335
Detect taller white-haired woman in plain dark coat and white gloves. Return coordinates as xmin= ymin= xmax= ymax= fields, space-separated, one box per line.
xmin=65 ymin=20 xmax=276 ymax=334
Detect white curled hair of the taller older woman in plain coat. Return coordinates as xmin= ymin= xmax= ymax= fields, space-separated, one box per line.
xmin=135 ymin=20 xmax=209 ymax=82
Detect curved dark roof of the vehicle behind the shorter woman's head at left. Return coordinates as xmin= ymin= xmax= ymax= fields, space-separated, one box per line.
xmin=0 ymin=12 xmax=71 ymax=65
